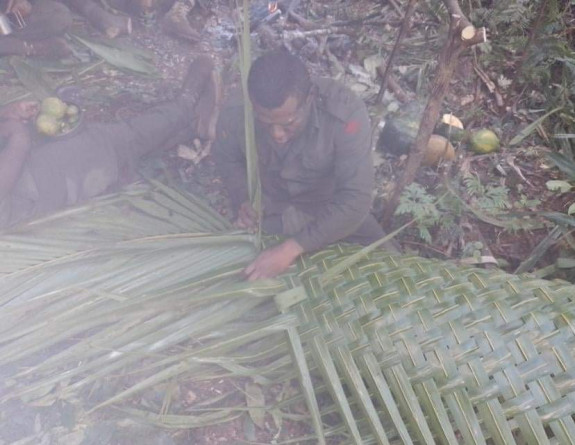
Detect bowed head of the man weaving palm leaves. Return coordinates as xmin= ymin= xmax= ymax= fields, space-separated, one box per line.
xmin=248 ymin=50 xmax=312 ymax=145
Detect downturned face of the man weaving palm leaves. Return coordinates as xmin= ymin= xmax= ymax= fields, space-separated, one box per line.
xmin=252 ymin=96 xmax=311 ymax=145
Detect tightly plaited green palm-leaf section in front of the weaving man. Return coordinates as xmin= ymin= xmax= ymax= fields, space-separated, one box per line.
xmin=280 ymin=247 xmax=575 ymax=444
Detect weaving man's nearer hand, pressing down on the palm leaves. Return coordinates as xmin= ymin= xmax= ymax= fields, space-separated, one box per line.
xmin=243 ymin=239 xmax=303 ymax=281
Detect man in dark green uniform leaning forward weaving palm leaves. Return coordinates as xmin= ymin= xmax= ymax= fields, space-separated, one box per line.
xmin=214 ymin=50 xmax=394 ymax=280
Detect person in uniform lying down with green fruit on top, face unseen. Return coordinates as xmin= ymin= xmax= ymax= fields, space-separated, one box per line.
xmin=0 ymin=56 xmax=218 ymax=227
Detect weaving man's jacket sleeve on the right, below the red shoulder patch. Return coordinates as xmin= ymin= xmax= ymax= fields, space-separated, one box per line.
xmin=294 ymin=100 xmax=374 ymax=251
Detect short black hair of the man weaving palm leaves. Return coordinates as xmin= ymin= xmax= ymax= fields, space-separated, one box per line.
xmin=248 ymin=49 xmax=311 ymax=109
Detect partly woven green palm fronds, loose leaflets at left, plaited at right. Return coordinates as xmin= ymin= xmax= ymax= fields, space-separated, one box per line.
xmin=0 ymin=184 xmax=575 ymax=444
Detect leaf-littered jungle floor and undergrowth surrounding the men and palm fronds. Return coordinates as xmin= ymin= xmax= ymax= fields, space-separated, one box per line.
xmin=0 ymin=0 xmax=575 ymax=444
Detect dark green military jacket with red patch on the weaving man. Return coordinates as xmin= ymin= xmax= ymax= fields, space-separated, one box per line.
xmin=214 ymin=79 xmax=374 ymax=251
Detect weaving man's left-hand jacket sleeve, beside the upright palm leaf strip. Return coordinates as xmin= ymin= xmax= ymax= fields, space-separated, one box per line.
xmin=212 ymin=106 xmax=249 ymax=215
